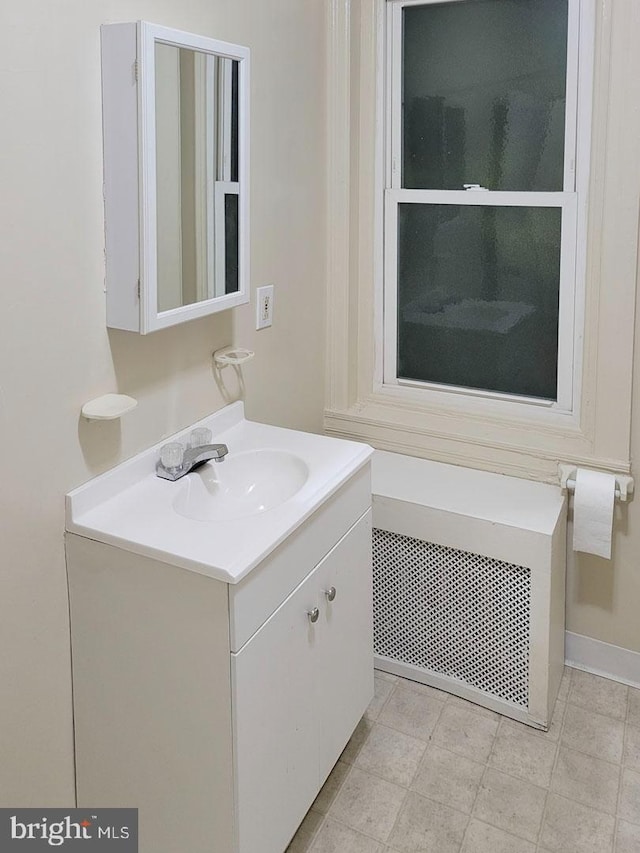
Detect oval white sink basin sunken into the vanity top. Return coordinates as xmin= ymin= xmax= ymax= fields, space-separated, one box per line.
xmin=173 ymin=450 xmax=309 ymax=521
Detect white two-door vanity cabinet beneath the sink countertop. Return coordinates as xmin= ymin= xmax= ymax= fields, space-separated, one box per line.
xmin=67 ymin=463 xmax=373 ymax=853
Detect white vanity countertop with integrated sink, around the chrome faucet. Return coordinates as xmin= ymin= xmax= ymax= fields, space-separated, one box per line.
xmin=66 ymin=402 xmax=373 ymax=583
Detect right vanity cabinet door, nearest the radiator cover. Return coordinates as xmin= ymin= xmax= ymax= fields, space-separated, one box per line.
xmin=316 ymin=510 xmax=373 ymax=783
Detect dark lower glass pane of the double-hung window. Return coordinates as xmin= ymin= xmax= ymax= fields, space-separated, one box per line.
xmin=397 ymin=204 xmax=562 ymax=400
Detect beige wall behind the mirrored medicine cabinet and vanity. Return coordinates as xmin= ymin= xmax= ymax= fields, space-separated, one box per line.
xmin=0 ymin=0 xmax=325 ymax=806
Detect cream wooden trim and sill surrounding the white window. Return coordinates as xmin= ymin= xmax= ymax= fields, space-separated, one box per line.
xmin=324 ymin=0 xmax=640 ymax=482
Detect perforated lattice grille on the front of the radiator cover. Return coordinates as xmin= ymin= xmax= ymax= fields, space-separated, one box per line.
xmin=373 ymin=529 xmax=531 ymax=708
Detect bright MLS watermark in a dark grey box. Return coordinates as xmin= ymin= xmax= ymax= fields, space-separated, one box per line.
xmin=0 ymin=809 xmax=138 ymax=853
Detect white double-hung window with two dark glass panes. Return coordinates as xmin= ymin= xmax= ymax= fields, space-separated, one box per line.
xmin=383 ymin=0 xmax=579 ymax=412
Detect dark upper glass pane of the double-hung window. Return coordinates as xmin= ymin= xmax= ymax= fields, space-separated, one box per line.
xmin=402 ymin=0 xmax=568 ymax=191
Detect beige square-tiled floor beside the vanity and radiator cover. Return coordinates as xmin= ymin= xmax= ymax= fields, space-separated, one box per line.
xmin=287 ymin=668 xmax=640 ymax=853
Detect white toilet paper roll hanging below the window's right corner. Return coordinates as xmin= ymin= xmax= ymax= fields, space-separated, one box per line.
xmin=573 ymin=468 xmax=616 ymax=560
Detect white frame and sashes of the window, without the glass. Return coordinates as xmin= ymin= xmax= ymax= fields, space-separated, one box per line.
xmin=382 ymin=0 xmax=591 ymax=420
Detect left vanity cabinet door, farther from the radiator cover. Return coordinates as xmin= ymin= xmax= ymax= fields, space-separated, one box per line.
xmin=231 ymin=569 xmax=320 ymax=853
